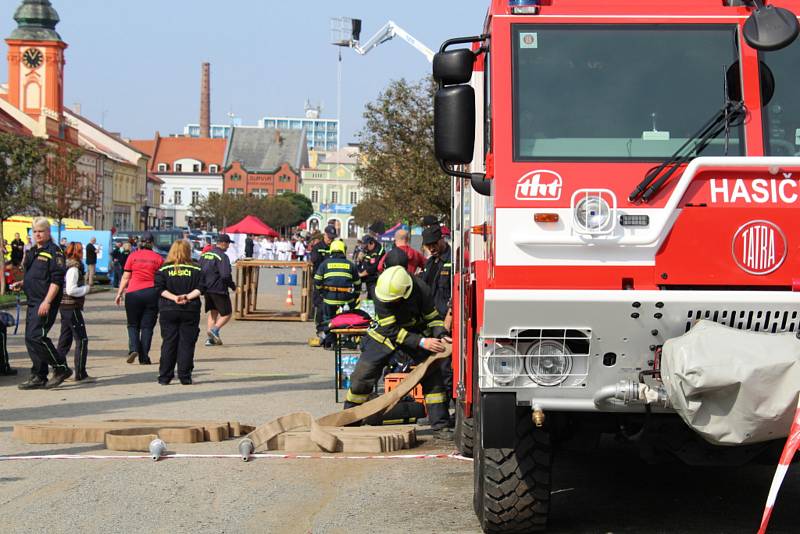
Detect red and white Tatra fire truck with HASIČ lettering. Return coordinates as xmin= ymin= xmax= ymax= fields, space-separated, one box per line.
xmin=433 ymin=0 xmax=800 ymax=532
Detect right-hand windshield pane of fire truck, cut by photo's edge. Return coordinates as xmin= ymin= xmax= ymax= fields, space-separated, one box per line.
xmin=761 ymin=41 xmax=800 ymax=156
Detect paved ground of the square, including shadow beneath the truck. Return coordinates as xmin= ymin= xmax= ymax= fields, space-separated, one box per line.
xmin=0 ymin=279 xmax=800 ymax=533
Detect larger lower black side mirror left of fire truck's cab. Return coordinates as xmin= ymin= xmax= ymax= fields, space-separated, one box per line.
xmin=433 ymin=85 xmax=475 ymax=165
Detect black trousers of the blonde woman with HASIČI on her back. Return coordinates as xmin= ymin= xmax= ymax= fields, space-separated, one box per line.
xmin=158 ymin=310 xmax=200 ymax=384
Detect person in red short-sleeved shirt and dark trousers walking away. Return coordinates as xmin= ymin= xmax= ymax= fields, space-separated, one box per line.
xmin=114 ymin=232 xmax=164 ymax=365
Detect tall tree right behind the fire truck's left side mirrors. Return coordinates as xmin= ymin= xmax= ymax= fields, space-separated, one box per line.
xmin=356 ymin=78 xmax=451 ymax=225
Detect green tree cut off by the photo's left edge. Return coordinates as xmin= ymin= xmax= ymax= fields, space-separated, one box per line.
xmin=0 ymin=133 xmax=47 ymax=295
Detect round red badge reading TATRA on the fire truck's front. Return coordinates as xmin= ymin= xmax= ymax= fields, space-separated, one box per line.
xmin=732 ymin=221 xmax=787 ymax=276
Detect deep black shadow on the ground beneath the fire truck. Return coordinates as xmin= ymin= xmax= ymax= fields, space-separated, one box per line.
xmin=548 ymin=450 xmax=800 ymax=534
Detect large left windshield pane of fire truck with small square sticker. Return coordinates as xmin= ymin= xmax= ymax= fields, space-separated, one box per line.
xmin=512 ymin=25 xmax=744 ymax=161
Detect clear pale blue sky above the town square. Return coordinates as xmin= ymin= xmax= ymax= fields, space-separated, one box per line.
xmin=0 ymin=0 xmax=489 ymax=142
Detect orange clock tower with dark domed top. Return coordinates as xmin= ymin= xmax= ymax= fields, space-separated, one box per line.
xmin=6 ymin=0 xmax=67 ymax=119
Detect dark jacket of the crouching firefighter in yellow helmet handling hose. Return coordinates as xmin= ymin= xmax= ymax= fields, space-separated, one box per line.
xmin=367 ymin=276 xmax=447 ymax=352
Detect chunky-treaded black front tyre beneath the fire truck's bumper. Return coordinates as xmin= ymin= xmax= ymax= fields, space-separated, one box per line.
xmin=473 ymin=402 xmax=553 ymax=534
